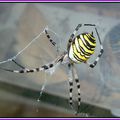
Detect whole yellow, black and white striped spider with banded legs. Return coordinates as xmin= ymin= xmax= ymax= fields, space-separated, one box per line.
xmin=1 ymin=24 xmax=103 ymax=114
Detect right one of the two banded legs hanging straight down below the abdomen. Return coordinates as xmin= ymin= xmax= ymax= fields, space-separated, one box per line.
xmin=73 ymin=66 xmax=81 ymax=114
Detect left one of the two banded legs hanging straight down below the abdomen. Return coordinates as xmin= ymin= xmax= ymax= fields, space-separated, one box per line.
xmin=68 ymin=63 xmax=73 ymax=109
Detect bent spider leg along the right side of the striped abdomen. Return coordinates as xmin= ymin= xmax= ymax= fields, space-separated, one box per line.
xmin=88 ymin=27 xmax=104 ymax=68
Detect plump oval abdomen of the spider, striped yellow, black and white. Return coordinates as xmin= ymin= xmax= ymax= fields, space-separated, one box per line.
xmin=68 ymin=33 xmax=96 ymax=63
